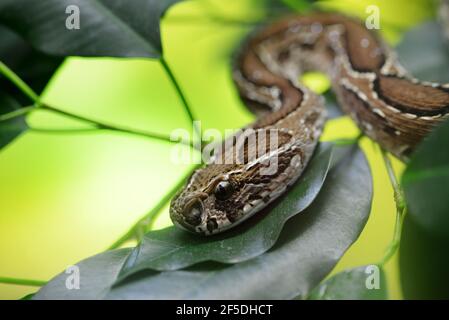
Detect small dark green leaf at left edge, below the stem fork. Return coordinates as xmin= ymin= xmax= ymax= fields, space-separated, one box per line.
xmin=0 ymin=93 xmax=28 ymax=149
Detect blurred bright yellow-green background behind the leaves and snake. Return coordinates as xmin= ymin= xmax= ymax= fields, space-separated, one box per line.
xmin=0 ymin=0 xmax=435 ymax=299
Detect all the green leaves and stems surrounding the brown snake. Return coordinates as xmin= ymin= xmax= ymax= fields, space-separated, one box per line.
xmin=0 ymin=0 xmax=449 ymax=299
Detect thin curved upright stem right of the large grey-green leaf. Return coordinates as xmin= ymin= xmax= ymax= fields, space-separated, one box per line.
xmin=379 ymin=149 xmax=407 ymax=265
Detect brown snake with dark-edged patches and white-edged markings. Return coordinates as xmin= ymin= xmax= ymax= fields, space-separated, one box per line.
xmin=170 ymin=12 xmax=449 ymax=236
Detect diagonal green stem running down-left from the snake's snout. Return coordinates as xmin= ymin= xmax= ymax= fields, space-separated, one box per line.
xmin=107 ymin=165 xmax=199 ymax=250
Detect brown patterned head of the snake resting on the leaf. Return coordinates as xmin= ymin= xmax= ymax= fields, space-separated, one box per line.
xmin=170 ymin=105 xmax=325 ymax=235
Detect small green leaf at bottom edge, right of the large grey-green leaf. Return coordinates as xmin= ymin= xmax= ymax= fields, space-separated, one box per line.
xmin=308 ymin=265 xmax=388 ymax=300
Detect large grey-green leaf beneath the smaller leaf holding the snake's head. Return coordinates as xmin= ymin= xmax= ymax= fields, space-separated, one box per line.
xmin=34 ymin=147 xmax=372 ymax=299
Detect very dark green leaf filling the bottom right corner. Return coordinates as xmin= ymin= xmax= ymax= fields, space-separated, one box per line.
xmin=399 ymin=214 xmax=449 ymax=299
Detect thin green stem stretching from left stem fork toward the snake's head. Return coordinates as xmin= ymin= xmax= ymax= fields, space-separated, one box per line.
xmin=40 ymin=104 xmax=191 ymax=146
